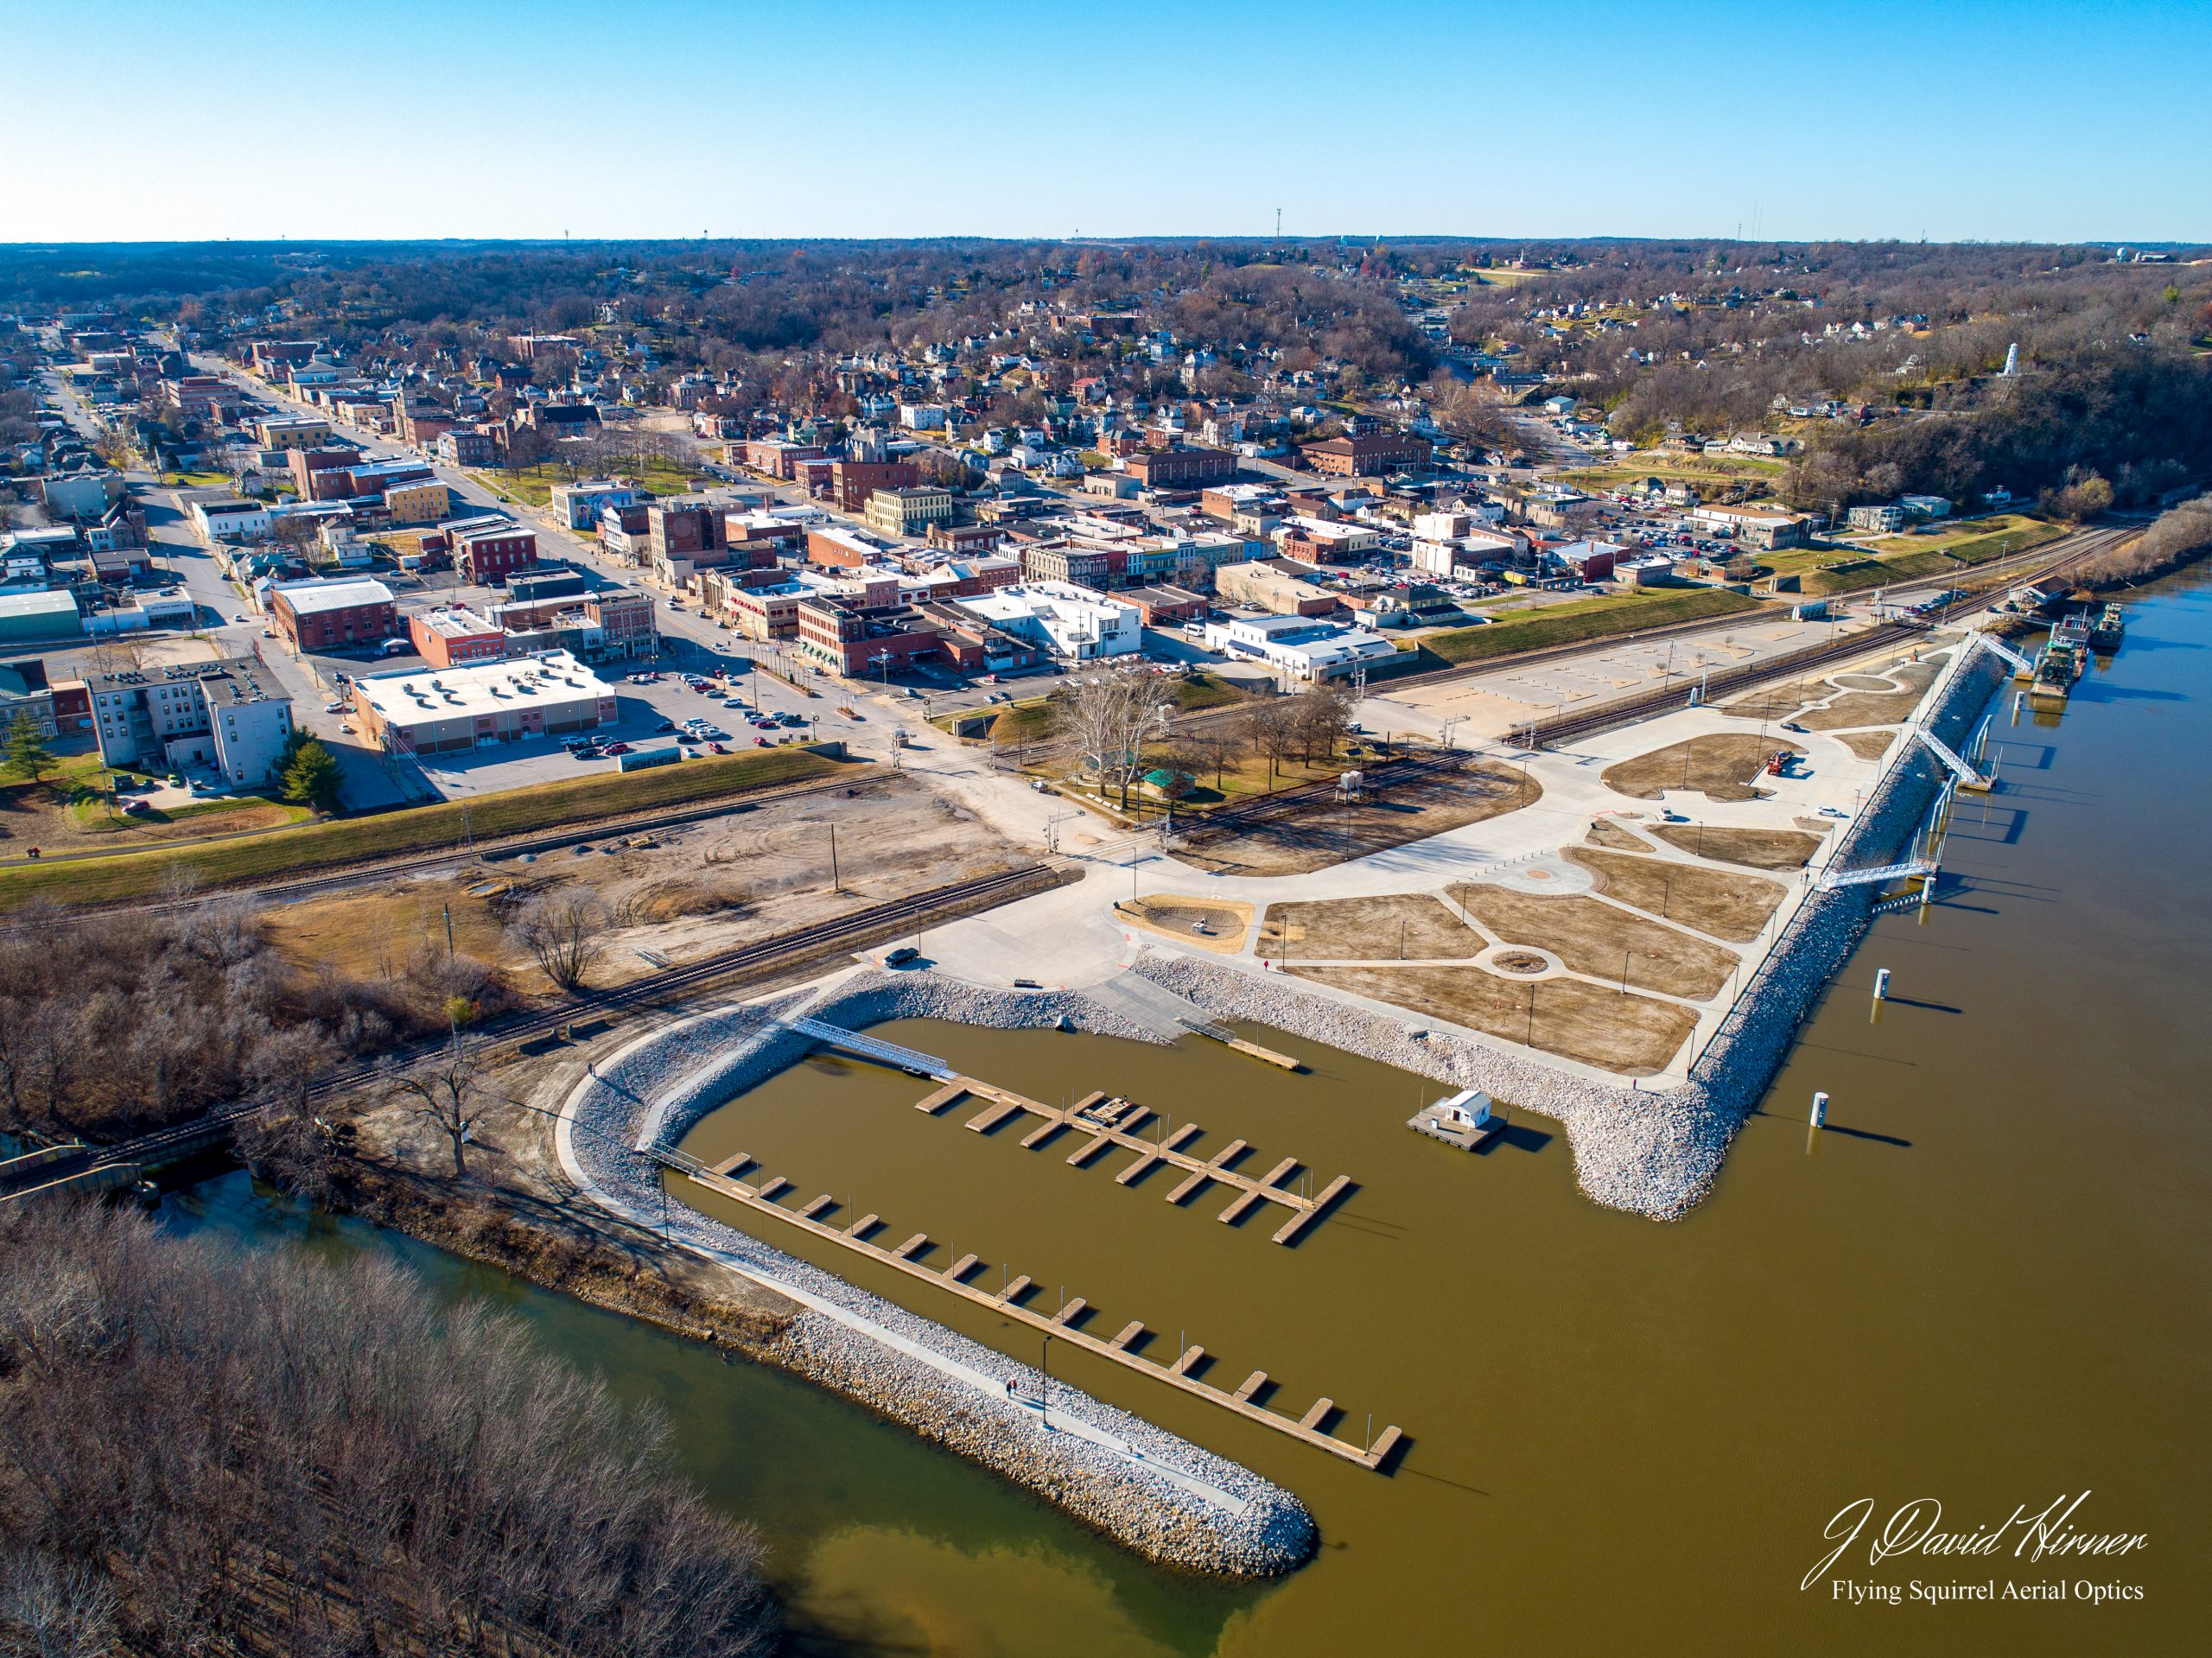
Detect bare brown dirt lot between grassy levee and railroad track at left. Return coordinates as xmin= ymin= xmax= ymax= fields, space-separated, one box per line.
xmin=270 ymin=774 xmax=1028 ymax=993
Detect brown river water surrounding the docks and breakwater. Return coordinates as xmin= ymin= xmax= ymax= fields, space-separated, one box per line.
xmin=173 ymin=577 xmax=2212 ymax=1658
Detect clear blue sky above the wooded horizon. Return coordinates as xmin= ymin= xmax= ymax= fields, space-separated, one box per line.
xmin=0 ymin=0 xmax=2212 ymax=241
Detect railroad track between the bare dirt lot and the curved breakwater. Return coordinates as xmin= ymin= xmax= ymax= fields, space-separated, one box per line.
xmin=0 ymin=864 xmax=1062 ymax=1200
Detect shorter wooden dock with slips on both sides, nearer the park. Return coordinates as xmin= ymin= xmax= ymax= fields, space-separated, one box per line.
xmin=913 ymin=1077 xmax=1351 ymax=1245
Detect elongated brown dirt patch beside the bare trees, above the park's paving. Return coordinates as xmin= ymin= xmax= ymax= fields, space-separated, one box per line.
xmin=1174 ymin=765 xmax=1544 ymax=875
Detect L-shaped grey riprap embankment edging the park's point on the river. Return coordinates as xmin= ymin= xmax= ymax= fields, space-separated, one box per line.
xmin=1135 ymin=654 xmax=2002 ymax=1220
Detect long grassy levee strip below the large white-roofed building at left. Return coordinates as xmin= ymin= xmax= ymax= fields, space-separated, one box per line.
xmin=0 ymin=747 xmax=836 ymax=909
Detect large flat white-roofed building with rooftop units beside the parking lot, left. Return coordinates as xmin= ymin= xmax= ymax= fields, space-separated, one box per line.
xmin=354 ymin=650 xmax=621 ymax=754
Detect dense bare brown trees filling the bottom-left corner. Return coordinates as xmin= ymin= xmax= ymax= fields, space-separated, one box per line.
xmin=0 ymin=1204 xmax=777 ymax=1658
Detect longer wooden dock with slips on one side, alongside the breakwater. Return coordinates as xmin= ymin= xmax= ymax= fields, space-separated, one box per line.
xmin=683 ymin=1167 xmax=1402 ymax=1468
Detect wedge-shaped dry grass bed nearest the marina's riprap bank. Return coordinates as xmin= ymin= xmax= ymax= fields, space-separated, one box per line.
xmin=1289 ymin=966 xmax=1697 ymax=1077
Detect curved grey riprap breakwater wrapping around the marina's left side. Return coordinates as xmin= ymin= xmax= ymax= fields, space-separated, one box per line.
xmin=564 ymin=970 xmax=1316 ymax=1576
